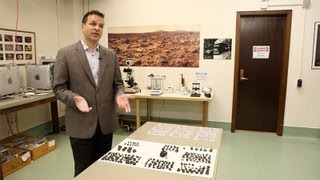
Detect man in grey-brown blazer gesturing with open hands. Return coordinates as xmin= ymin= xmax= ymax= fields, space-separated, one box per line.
xmin=53 ymin=10 xmax=131 ymax=176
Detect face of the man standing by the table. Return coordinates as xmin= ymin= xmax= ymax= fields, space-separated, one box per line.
xmin=81 ymin=15 xmax=104 ymax=43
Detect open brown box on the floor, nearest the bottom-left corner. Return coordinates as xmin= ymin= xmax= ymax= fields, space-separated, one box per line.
xmin=1 ymin=148 xmax=31 ymax=176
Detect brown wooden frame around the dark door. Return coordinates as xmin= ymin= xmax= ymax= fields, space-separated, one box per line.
xmin=231 ymin=10 xmax=292 ymax=136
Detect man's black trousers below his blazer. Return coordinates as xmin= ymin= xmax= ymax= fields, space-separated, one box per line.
xmin=70 ymin=123 xmax=113 ymax=177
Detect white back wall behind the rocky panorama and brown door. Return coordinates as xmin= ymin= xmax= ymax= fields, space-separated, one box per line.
xmin=89 ymin=0 xmax=320 ymax=128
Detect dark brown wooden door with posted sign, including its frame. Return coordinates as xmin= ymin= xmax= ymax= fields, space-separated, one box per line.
xmin=231 ymin=10 xmax=291 ymax=135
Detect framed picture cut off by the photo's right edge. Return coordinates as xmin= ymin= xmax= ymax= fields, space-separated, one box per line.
xmin=311 ymin=22 xmax=320 ymax=69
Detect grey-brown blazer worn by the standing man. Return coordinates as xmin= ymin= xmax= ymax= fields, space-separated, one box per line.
xmin=53 ymin=41 xmax=124 ymax=138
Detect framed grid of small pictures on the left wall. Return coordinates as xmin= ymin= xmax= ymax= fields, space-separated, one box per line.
xmin=0 ymin=28 xmax=36 ymax=65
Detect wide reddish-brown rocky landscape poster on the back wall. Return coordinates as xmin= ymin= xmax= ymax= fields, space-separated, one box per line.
xmin=108 ymin=30 xmax=200 ymax=67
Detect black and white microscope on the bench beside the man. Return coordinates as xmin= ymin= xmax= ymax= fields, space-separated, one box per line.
xmin=123 ymin=56 xmax=140 ymax=94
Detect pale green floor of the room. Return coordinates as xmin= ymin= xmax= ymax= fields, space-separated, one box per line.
xmin=4 ymin=124 xmax=320 ymax=180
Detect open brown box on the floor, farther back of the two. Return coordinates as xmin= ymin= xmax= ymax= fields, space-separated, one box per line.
xmin=2 ymin=135 xmax=56 ymax=160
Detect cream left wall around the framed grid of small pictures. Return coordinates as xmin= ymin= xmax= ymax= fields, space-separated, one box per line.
xmin=0 ymin=0 xmax=58 ymax=138
